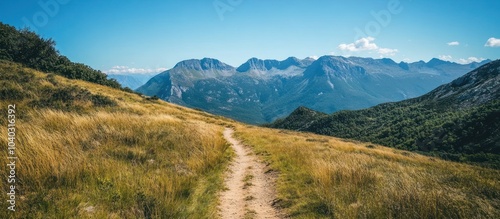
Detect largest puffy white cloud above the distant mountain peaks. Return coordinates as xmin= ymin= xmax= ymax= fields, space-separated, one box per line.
xmin=338 ymin=37 xmax=398 ymax=57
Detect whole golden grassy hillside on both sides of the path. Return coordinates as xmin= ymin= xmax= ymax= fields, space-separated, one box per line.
xmin=0 ymin=61 xmax=500 ymax=218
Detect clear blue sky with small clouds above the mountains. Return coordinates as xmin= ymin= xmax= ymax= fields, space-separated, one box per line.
xmin=0 ymin=0 xmax=500 ymax=73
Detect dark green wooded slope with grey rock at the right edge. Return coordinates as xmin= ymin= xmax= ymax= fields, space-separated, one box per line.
xmin=270 ymin=60 xmax=500 ymax=168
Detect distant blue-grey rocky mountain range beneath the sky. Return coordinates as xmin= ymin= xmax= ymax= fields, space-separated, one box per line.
xmin=136 ymin=56 xmax=489 ymax=124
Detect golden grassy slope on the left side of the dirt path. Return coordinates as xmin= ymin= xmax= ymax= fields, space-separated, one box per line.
xmin=0 ymin=61 xmax=230 ymax=218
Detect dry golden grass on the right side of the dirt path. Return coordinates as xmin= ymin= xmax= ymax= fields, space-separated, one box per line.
xmin=237 ymin=126 xmax=500 ymax=218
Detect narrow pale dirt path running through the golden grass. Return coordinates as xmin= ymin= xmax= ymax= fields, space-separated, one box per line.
xmin=219 ymin=128 xmax=280 ymax=219
